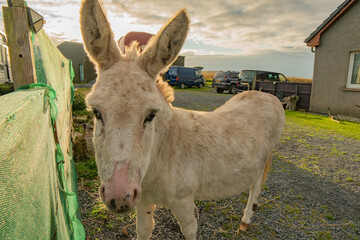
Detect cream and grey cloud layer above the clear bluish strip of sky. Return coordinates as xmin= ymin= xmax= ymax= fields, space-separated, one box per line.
xmin=0 ymin=0 xmax=342 ymax=54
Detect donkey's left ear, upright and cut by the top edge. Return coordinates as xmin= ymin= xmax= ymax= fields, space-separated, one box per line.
xmin=80 ymin=0 xmax=121 ymax=69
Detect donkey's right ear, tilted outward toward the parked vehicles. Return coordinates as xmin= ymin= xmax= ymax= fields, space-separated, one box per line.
xmin=141 ymin=9 xmax=190 ymax=77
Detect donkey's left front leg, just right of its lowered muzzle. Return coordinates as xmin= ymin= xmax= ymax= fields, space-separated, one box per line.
xmin=136 ymin=197 xmax=155 ymax=240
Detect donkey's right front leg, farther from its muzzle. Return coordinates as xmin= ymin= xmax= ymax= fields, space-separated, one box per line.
xmin=171 ymin=199 xmax=197 ymax=240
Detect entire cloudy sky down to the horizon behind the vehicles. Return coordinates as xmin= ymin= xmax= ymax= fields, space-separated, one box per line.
xmin=0 ymin=0 xmax=344 ymax=78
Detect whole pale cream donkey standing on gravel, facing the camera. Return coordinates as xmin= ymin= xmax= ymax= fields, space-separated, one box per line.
xmin=80 ymin=0 xmax=285 ymax=240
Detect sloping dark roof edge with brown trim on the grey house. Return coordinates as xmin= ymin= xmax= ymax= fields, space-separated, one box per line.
xmin=305 ymin=0 xmax=358 ymax=47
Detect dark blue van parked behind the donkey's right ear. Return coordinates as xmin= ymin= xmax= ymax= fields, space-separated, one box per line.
xmin=164 ymin=66 xmax=205 ymax=89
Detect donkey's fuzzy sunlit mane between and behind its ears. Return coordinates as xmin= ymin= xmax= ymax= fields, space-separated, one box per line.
xmin=122 ymin=41 xmax=175 ymax=103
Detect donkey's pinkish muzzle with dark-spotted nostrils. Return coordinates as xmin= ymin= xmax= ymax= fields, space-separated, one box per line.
xmin=100 ymin=164 xmax=141 ymax=213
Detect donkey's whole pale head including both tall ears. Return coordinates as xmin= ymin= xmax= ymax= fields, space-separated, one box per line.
xmin=80 ymin=0 xmax=189 ymax=213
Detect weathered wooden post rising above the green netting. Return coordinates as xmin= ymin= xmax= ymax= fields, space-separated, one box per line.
xmin=3 ymin=0 xmax=37 ymax=89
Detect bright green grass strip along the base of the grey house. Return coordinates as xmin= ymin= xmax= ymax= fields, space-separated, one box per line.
xmin=285 ymin=111 xmax=360 ymax=140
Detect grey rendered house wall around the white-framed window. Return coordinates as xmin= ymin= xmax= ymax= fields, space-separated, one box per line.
xmin=310 ymin=1 xmax=360 ymax=118
